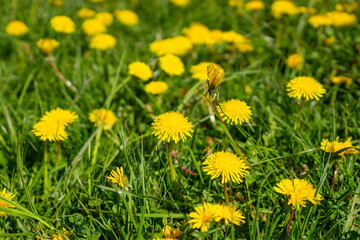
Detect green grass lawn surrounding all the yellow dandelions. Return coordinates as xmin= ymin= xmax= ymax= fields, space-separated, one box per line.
xmin=0 ymin=0 xmax=360 ymax=240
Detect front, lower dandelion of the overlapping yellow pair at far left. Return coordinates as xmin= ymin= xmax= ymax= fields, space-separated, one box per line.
xmin=31 ymin=121 xmax=68 ymax=142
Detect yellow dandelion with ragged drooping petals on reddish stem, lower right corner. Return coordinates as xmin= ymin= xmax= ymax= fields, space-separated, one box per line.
xmin=274 ymin=178 xmax=322 ymax=210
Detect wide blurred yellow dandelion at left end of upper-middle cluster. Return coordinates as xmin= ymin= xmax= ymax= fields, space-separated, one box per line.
xmin=150 ymin=36 xmax=193 ymax=56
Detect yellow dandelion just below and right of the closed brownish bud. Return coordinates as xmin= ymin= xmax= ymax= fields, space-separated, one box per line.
xmin=220 ymin=99 xmax=252 ymax=125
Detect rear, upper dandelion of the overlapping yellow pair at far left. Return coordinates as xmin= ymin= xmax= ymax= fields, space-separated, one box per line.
xmin=41 ymin=107 xmax=78 ymax=126
